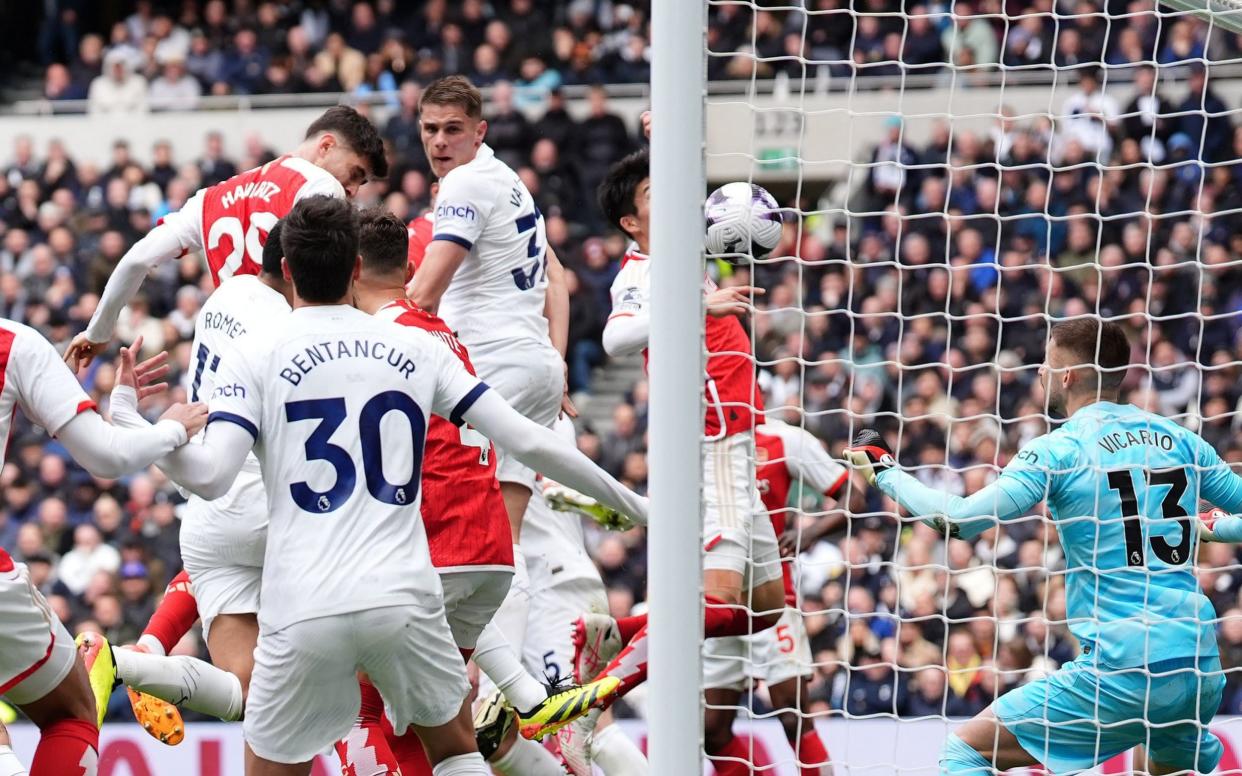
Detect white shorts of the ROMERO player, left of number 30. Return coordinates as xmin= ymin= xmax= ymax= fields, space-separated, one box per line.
xmin=180 ymin=469 xmax=267 ymax=638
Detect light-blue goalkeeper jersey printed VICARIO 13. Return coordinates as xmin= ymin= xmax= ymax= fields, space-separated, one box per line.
xmin=996 ymin=401 xmax=1232 ymax=668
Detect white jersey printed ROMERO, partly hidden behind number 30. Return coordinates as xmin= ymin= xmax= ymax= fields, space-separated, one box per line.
xmin=185 ymin=274 xmax=291 ymax=472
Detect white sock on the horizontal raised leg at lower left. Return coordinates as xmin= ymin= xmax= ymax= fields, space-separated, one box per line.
xmin=112 ymin=649 xmax=242 ymax=723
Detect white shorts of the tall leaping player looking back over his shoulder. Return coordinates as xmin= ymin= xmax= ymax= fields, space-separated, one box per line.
xmin=469 ymin=340 xmax=565 ymax=492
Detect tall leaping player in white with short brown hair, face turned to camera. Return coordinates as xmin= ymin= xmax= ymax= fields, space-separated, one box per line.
xmin=410 ymin=76 xmax=569 ymax=739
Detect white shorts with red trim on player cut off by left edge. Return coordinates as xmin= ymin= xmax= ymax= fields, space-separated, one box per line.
xmin=0 ymin=564 xmax=77 ymax=706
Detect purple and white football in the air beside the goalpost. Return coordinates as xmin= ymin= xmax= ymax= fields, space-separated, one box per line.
xmin=703 ymin=181 xmax=782 ymax=261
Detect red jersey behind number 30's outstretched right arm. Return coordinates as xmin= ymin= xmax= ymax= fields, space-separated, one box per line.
xmin=376 ymin=299 xmax=513 ymax=572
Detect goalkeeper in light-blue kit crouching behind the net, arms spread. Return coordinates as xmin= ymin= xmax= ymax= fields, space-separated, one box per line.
xmin=846 ymin=318 xmax=1242 ymax=776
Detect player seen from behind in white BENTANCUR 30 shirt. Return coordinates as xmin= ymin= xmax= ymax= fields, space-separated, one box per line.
xmin=133 ymin=197 xmax=647 ymax=776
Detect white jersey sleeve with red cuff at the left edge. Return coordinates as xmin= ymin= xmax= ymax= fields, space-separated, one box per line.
xmin=0 ymin=318 xmax=94 ymax=452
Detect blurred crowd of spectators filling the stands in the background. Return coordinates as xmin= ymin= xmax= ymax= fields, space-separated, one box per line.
xmin=7 ymin=0 xmax=1242 ymax=716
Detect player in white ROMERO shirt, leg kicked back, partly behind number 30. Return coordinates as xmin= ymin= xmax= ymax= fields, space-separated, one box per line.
xmin=87 ymin=222 xmax=293 ymax=745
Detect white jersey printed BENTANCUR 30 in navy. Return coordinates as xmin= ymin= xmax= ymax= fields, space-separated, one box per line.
xmin=207 ymin=305 xmax=487 ymax=631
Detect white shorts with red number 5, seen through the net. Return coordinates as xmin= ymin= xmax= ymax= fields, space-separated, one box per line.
xmin=703 ymin=607 xmax=815 ymax=690
